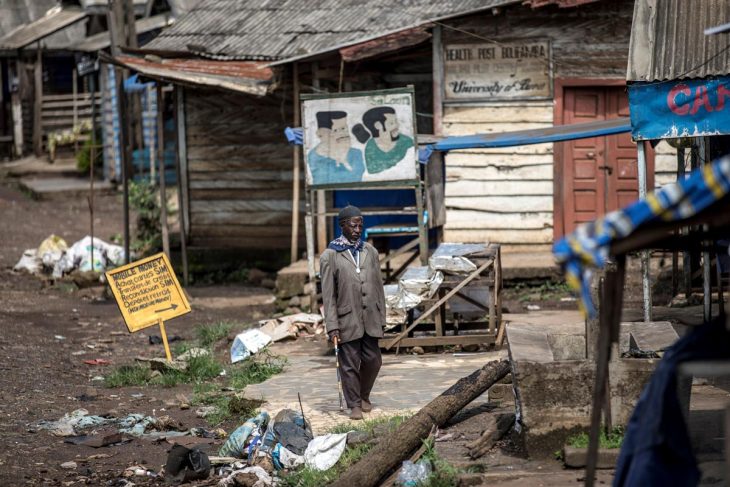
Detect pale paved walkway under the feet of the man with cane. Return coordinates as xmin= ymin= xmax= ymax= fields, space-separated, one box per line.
xmin=245 ymin=340 xmax=507 ymax=434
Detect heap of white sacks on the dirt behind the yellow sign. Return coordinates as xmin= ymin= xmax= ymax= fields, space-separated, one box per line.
xmin=13 ymin=235 xmax=124 ymax=279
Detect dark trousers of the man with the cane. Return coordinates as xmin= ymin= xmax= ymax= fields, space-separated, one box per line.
xmin=339 ymin=335 xmax=383 ymax=408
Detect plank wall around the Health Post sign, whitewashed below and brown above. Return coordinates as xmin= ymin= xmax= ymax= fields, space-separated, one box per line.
xmin=443 ymin=0 xmax=632 ymax=251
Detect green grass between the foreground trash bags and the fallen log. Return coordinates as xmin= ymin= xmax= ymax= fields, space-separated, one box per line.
xmin=281 ymin=416 xmax=409 ymax=487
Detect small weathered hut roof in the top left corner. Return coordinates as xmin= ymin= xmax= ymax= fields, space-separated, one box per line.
xmin=0 ymin=6 xmax=87 ymax=51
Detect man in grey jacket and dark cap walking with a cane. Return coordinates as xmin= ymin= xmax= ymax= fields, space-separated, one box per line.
xmin=320 ymin=206 xmax=385 ymax=419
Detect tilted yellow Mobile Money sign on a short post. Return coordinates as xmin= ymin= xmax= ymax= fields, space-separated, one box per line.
xmin=106 ymin=253 xmax=191 ymax=362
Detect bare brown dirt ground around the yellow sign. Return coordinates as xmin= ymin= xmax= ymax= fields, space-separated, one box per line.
xmin=0 ymin=182 xmax=273 ymax=486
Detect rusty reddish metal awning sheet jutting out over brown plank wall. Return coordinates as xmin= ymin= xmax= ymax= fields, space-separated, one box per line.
xmin=114 ymin=55 xmax=275 ymax=96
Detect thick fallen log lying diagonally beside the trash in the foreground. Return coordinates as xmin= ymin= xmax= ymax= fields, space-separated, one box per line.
xmin=332 ymin=360 xmax=510 ymax=487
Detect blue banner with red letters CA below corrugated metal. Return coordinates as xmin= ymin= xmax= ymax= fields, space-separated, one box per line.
xmin=629 ymin=77 xmax=730 ymax=140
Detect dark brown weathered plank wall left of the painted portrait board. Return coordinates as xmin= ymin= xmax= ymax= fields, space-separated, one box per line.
xmin=185 ymin=89 xmax=303 ymax=249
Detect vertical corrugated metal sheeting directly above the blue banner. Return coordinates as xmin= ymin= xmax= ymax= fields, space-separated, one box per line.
xmin=626 ymin=0 xmax=730 ymax=81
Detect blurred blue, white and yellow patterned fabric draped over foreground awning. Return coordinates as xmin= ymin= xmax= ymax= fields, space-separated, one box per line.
xmin=553 ymin=155 xmax=730 ymax=317
